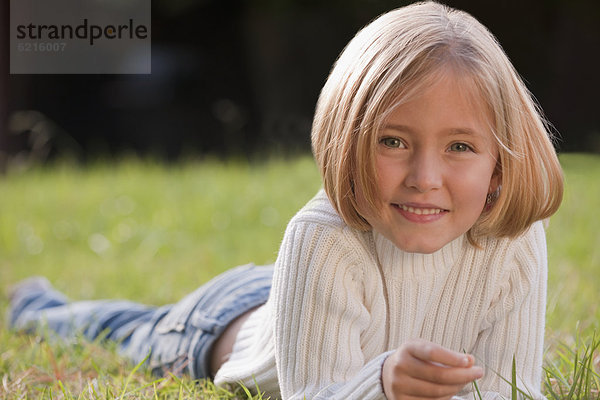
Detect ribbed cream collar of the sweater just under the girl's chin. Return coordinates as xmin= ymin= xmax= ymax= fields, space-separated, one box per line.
xmin=373 ymin=231 xmax=469 ymax=277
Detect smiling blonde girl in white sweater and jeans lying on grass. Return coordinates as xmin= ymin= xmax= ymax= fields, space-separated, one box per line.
xmin=11 ymin=2 xmax=562 ymax=399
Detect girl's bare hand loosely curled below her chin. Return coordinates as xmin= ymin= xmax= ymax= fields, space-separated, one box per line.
xmin=381 ymin=339 xmax=483 ymax=400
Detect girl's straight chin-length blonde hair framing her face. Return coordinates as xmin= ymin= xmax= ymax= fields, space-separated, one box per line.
xmin=312 ymin=2 xmax=563 ymax=243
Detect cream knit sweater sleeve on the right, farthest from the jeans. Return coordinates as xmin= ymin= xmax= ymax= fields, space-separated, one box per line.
xmin=455 ymin=222 xmax=547 ymax=400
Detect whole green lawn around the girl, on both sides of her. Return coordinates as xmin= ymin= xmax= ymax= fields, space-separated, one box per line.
xmin=0 ymin=154 xmax=600 ymax=399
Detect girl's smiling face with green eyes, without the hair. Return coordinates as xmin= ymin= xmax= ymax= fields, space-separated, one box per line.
xmin=357 ymin=73 xmax=499 ymax=253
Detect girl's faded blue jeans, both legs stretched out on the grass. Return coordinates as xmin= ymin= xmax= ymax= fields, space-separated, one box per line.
xmin=9 ymin=264 xmax=273 ymax=379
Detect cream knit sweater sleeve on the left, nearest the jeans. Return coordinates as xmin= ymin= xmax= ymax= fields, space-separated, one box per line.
xmin=271 ymin=221 xmax=387 ymax=400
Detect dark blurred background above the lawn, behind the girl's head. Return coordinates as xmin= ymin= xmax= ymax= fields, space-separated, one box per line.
xmin=0 ymin=0 xmax=600 ymax=165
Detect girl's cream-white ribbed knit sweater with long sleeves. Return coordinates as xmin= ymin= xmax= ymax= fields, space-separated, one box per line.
xmin=215 ymin=191 xmax=547 ymax=400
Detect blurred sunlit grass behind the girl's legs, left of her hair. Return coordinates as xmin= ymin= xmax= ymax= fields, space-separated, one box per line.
xmin=0 ymin=157 xmax=320 ymax=304
